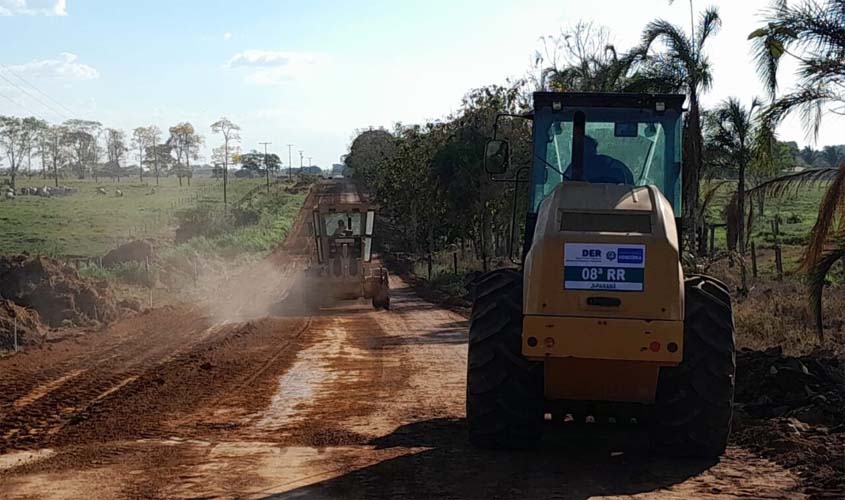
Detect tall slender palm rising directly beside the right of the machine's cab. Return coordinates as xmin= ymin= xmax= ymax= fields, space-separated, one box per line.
xmin=634 ymin=7 xmax=722 ymax=250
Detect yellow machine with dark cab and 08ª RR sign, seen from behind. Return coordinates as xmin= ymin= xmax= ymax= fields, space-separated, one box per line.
xmin=466 ymin=92 xmax=735 ymax=457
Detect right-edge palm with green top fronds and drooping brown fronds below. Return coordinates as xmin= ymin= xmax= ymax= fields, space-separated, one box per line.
xmin=748 ymin=0 xmax=845 ymax=340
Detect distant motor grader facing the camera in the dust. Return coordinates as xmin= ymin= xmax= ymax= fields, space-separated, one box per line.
xmin=301 ymin=180 xmax=390 ymax=309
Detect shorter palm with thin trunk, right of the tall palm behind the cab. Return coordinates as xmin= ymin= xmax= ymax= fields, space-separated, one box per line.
xmin=705 ymin=97 xmax=775 ymax=252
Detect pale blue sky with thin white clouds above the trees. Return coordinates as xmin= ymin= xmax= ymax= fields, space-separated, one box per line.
xmin=0 ymin=0 xmax=845 ymax=166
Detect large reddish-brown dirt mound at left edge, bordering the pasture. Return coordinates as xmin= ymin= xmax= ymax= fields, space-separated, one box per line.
xmin=0 ymin=255 xmax=120 ymax=327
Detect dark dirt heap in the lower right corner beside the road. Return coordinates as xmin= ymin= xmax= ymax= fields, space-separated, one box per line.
xmin=732 ymin=348 xmax=845 ymax=498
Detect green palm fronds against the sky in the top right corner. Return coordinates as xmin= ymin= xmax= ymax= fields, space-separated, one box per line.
xmin=748 ymin=0 xmax=845 ymax=139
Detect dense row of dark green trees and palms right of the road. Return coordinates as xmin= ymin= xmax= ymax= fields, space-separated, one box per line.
xmin=345 ymin=0 xmax=845 ymax=267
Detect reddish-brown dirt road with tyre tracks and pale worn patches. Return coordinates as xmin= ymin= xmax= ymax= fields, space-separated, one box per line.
xmin=0 ymin=183 xmax=802 ymax=500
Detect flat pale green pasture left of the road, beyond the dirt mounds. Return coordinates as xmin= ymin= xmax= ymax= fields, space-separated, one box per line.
xmin=0 ymin=177 xmax=263 ymax=257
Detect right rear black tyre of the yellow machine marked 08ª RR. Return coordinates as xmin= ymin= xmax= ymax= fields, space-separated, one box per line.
xmin=651 ymin=276 xmax=736 ymax=458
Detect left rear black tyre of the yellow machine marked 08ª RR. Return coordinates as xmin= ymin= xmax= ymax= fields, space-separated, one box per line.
xmin=466 ymin=269 xmax=543 ymax=449
